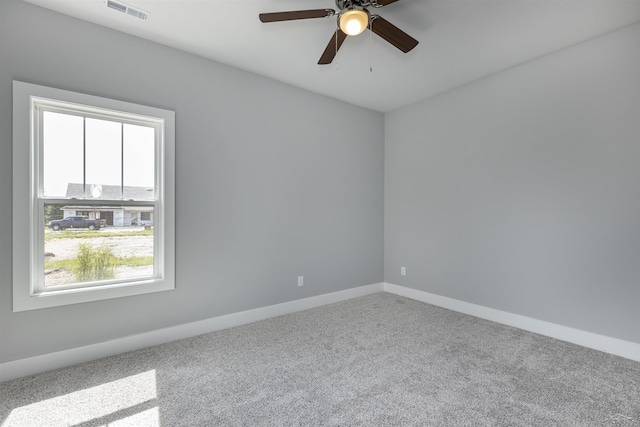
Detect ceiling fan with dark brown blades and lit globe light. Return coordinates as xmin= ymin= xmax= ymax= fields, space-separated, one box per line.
xmin=259 ymin=0 xmax=418 ymax=64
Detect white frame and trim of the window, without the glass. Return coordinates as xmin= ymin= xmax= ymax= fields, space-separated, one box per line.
xmin=13 ymin=81 xmax=175 ymax=312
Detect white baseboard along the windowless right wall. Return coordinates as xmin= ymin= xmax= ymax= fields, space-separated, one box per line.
xmin=384 ymin=283 xmax=640 ymax=362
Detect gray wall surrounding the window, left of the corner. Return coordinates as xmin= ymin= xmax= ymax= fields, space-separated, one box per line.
xmin=0 ymin=0 xmax=384 ymax=361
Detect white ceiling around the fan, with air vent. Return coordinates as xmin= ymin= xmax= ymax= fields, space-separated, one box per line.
xmin=20 ymin=0 xmax=640 ymax=112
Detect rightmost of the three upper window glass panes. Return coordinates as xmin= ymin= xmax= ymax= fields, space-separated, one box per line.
xmin=123 ymin=124 xmax=155 ymax=200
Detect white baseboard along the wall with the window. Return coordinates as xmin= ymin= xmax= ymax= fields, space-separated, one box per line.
xmin=0 ymin=283 xmax=384 ymax=382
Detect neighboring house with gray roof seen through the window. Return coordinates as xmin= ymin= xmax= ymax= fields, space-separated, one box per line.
xmin=61 ymin=183 xmax=154 ymax=227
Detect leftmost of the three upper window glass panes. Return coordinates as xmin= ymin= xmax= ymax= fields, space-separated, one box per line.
xmin=42 ymin=111 xmax=84 ymax=197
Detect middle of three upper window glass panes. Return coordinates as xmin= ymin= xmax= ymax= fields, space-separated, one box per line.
xmin=85 ymin=118 xmax=122 ymax=199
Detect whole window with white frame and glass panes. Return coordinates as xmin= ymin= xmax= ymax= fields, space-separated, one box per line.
xmin=13 ymin=81 xmax=175 ymax=311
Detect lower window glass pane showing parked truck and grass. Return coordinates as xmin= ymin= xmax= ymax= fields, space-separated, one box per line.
xmin=44 ymin=203 xmax=154 ymax=287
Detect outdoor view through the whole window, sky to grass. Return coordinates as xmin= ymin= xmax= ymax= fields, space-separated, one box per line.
xmin=38 ymin=108 xmax=156 ymax=288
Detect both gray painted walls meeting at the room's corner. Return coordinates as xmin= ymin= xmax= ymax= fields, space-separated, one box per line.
xmin=0 ymin=0 xmax=640 ymax=361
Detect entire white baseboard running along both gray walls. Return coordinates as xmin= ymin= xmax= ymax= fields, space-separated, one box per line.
xmin=0 ymin=283 xmax=640 ymax=382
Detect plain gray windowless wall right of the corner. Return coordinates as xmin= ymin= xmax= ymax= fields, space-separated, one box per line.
xmin=385 ymin=25 xmax=640 ymax=343
